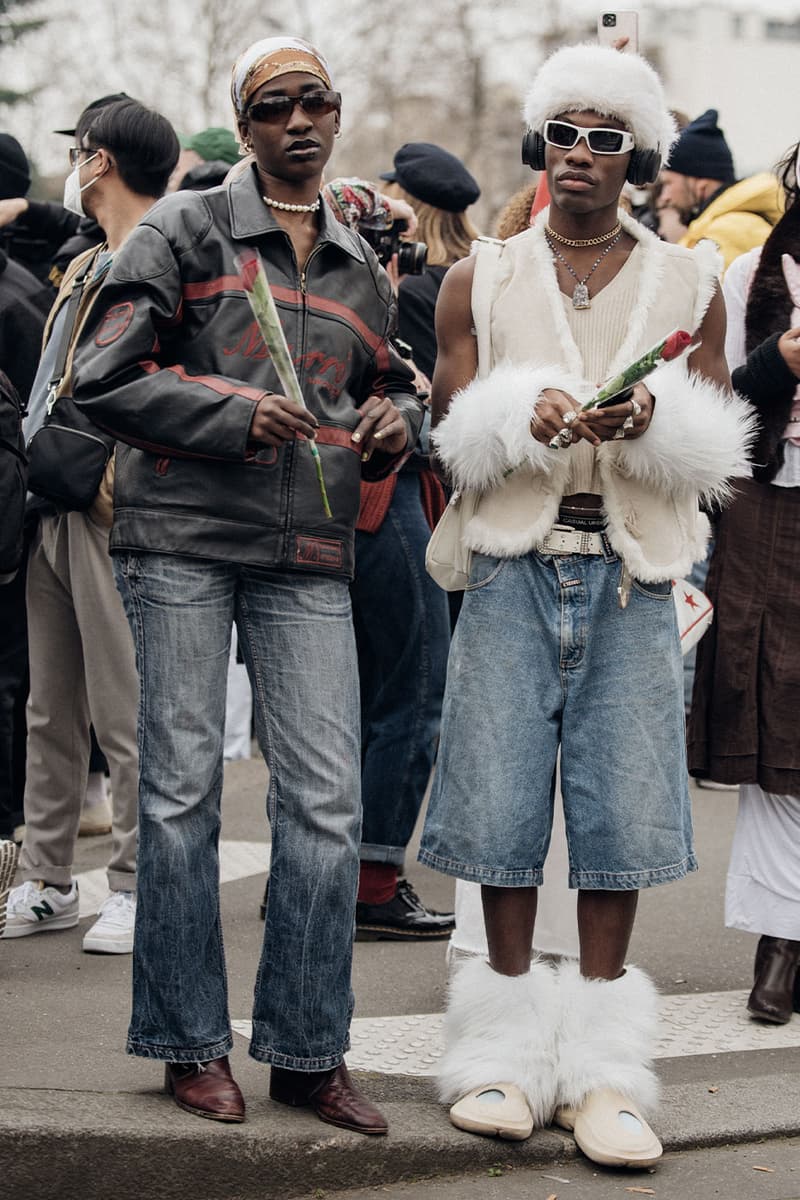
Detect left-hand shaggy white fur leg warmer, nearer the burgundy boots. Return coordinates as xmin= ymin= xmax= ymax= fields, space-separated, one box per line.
xmin=439 ymin=959 xmax=559 ymax=1126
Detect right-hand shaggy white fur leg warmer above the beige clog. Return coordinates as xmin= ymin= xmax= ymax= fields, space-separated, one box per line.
xmin=558 ymin=961 xmax=658 ymax=1111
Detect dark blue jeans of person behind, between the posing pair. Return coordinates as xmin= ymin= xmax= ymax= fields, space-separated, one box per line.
xmin=350 ymin=472 xmax=450 ymax=868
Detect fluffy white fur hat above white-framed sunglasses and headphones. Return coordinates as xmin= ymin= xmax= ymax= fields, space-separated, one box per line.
xmin=523 ymin=44 xmax=678 ymax=154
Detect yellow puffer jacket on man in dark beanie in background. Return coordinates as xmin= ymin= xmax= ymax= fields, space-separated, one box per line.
xmin=680 ymin=172 xmax=783 ymax=270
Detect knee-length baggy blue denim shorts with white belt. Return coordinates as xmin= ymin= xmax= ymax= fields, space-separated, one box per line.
xmin=420 ymin=550 xmax=697 ymax=890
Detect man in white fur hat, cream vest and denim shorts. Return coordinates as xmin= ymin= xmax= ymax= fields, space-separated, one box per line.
xmin=420 ymin=46 xmax=752 ymax=1166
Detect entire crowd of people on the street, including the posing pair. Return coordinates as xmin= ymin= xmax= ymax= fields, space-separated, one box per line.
xmin=0 ymin=28 xmax=800 ymax=1166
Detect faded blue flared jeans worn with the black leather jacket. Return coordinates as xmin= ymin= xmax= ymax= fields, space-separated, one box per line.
xmin=115 ymin=553 xmax=361 ymax=1070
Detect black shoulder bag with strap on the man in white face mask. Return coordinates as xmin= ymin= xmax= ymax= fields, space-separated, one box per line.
xmin=28 ymin=257 xmax=115 ymax=510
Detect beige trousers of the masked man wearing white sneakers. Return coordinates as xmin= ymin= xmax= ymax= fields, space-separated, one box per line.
xmin=19 ymin=512 xmax=139 ymax=892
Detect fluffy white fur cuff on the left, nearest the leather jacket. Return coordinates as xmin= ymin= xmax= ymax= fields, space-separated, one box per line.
xmin=431 ymin=362 xmax=591 ymax=491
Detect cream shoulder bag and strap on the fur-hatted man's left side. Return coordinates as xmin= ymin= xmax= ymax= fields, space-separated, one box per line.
xmin=425 ymin=238 xmax=504 ymax=592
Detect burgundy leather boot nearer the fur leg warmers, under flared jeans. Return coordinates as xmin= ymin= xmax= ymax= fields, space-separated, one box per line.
xmin=270 ymin=1062 xmax=389 ymax=1134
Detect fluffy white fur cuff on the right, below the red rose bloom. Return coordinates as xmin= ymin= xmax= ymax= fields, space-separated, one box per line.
xmin=612 ymin=361 xmax=758 ymax=504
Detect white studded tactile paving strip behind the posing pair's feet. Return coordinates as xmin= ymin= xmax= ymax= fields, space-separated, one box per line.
xmin=233 ymin=991 xmax=800 ymax=1075
